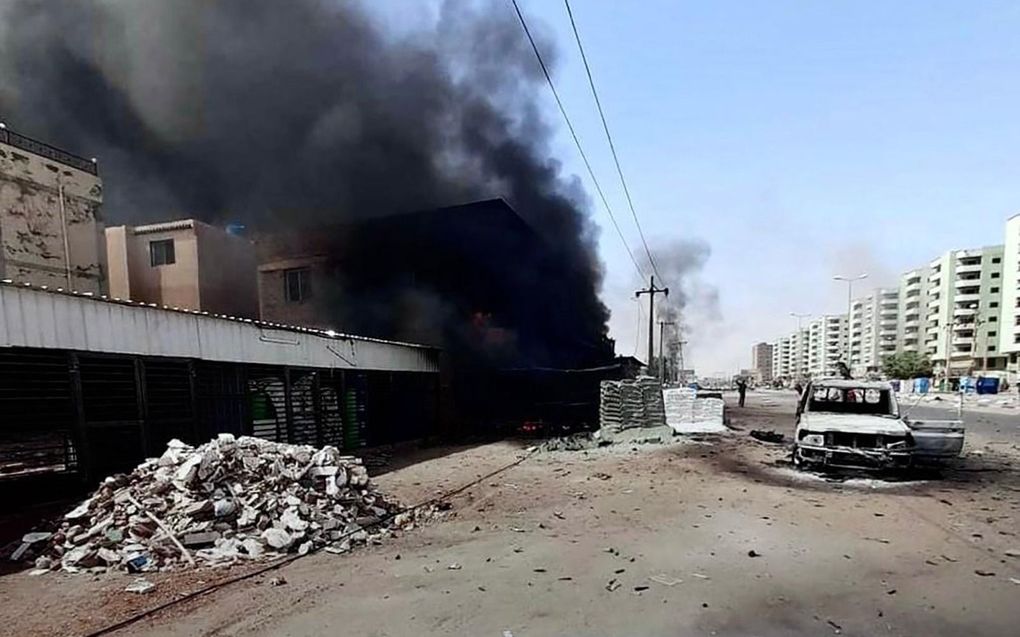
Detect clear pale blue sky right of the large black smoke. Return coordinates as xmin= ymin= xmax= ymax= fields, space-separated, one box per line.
xmin=507 ymin=0 xmax=1020 ymax=373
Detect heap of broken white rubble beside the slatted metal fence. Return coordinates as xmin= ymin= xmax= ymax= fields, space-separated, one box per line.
xmin=11 ymin=434 xmax=428 ymax=572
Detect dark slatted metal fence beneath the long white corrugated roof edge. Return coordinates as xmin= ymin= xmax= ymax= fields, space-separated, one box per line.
xmin=0 ymin=348 xmax=439 ymax=495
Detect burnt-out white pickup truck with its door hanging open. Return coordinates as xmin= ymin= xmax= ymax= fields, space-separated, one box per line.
xmin=794 ymin=379 xmax=964 ymax=469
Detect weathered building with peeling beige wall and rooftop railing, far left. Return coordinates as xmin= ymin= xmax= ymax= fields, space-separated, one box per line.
xmin=0 ymin=124 xmax=106 ymax=295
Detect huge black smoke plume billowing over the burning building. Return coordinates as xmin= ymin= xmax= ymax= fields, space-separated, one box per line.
xmin=0 ymin=0 xmax=608 ymax=364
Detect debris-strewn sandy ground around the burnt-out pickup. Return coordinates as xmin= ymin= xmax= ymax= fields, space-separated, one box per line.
xmin=0 ymin=392 xmax=1020 ymax=637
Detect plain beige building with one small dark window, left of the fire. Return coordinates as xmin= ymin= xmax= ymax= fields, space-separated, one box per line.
xmin=106 ymin=219 xmax=259 ymax=318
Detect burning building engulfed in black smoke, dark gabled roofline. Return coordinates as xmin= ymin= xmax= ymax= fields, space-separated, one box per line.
xmin=258 ymin=199 xmax=613 ymax=368
